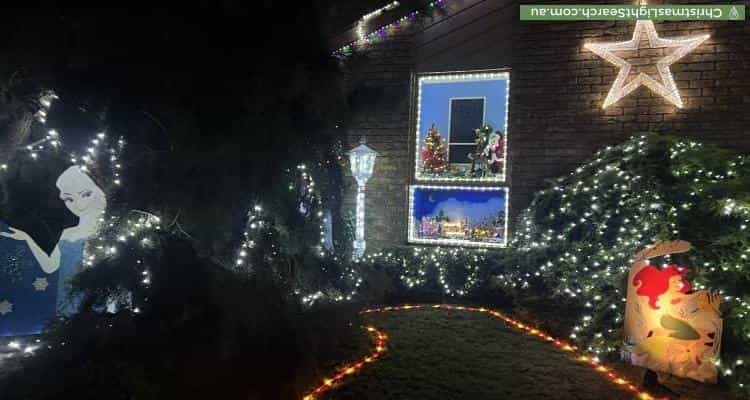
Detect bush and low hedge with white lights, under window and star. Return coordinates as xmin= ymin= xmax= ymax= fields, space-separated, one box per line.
xmin=332 ymin=134 xmax=750 ymax=392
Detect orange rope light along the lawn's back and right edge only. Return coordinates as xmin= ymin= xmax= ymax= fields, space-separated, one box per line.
xmin=360 ymin=304 xmax=669 ymax=400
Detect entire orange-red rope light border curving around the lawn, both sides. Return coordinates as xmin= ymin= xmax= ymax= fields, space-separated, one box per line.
xmin=303 ymin=304 xmax=669 ymax=400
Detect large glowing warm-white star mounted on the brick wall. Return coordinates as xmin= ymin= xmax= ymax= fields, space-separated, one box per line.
xmin=584 ymin=21 xmax=710 ymax=108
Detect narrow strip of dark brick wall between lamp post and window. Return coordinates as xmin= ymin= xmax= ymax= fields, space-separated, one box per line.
xmin=344 ymin=32 xmax=414 ymax=250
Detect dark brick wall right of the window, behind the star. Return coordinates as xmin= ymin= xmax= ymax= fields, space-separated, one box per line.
xmin=510 ymin=17 xmax=750 ymax=223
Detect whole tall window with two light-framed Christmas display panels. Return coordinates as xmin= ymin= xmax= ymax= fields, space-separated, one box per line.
xmin=408 ymin=71 xmax=509 ymax=247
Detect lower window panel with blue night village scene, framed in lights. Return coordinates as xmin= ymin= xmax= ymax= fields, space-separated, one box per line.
xmin=409 ymin=185 xmax=508 ymax=247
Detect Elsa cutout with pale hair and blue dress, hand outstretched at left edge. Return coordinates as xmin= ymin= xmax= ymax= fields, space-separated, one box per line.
xmin=0 ymin=166 xmax=107 ymax=335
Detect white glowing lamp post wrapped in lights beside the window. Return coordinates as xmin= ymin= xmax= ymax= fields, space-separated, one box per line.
xmin=349 ymin=138 xmax=378 ymax=259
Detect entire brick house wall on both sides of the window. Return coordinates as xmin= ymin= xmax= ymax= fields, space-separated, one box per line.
xmin=347 ymin=3 xmax=750 ymax=249
